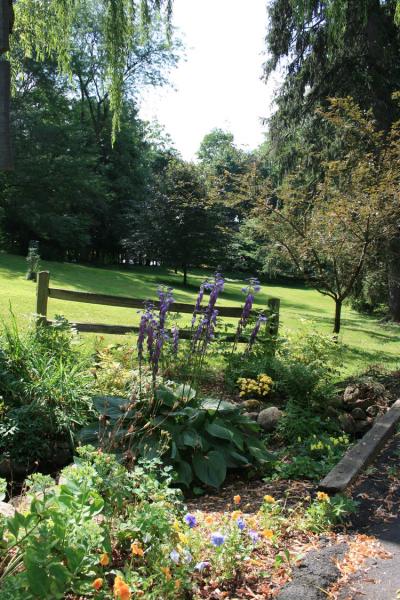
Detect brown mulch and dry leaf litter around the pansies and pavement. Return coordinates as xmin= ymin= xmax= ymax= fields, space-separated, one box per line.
xmin=187 ymin=479 xmax=390 ymax=600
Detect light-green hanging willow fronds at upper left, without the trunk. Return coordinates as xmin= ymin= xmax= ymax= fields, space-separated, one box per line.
xmin=12 ymin=0 xmax=172 ymax=141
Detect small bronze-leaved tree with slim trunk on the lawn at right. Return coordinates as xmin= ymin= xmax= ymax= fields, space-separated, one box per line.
xmin=257 ymin=99 xmax=400 ymax=333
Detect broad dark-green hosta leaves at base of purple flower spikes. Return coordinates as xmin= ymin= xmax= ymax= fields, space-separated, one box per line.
xmin=79 ymin=385 xmax=270 ymax=488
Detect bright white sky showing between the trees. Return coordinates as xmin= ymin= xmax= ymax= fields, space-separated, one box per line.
xmin=140 ymin=0 xmax=277 ymax=160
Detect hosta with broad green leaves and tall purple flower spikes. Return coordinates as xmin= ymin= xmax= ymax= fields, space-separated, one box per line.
xmin=81 ymin=273 xmax=270 ymax=487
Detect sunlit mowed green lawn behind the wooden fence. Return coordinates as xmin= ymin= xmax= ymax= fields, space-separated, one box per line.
xmin=0 ymin=253 xmax=400 ymax=374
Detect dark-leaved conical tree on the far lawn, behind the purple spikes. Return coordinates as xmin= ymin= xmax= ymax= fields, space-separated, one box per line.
xmin=126 ymin=155 xmax=224 ymax=285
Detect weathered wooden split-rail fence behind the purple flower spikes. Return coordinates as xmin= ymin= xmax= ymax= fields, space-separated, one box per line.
xmin=36 ymin=271 xmax=280 ymax=342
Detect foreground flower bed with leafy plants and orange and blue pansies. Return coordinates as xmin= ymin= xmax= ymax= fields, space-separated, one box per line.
xmin=0 ymin=447 xmax=354 ymax=600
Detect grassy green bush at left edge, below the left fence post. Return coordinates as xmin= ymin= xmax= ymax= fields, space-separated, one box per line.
xmin=0 ymin=319 xmax=93 ymax=466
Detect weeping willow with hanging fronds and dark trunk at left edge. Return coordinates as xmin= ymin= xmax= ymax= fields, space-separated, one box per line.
xmin=0 ymin=0 xmax=172 ymax=169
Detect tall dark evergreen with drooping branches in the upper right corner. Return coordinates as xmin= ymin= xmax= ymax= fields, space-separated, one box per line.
xmin=266 ymin=0 xmax=400 ymax=321
